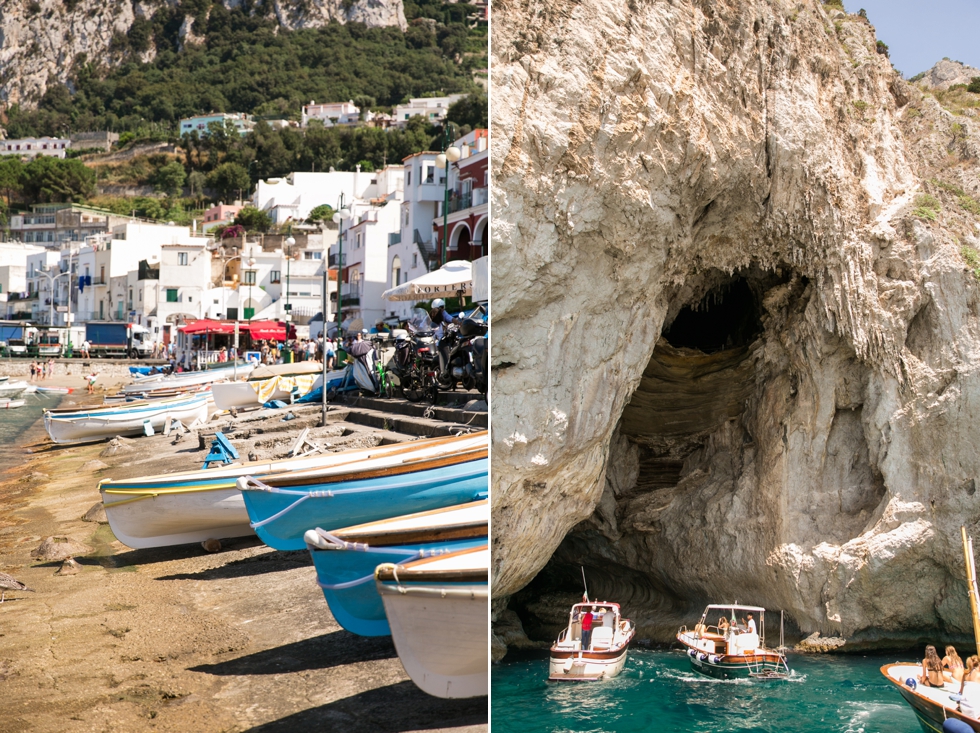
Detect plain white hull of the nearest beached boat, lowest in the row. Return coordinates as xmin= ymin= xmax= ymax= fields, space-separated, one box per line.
xmin=377 ymin=581 xmax=490 ymax=698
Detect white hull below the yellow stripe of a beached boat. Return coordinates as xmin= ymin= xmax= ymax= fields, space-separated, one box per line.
xmin=102 ymin=487 xmax=255 ymax=549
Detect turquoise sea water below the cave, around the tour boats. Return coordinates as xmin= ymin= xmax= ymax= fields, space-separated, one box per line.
xmin=490 ymin=649 xmax=921 ymax=733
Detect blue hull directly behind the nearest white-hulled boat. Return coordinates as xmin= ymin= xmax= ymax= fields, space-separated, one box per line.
xmin=310 ymin=537 xmax=487 ymax=636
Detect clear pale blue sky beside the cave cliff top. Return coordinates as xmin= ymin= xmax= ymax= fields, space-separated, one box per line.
xmin=844 ymin=0 xmax=980 ymax=79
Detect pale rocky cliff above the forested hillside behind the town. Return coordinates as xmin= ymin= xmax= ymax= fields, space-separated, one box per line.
xmin=0 ymin=0 xmax=406 ymax=106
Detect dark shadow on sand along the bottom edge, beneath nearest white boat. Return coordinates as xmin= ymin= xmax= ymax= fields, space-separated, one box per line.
xmin=234 ymin=680 xmax=488 ymax=733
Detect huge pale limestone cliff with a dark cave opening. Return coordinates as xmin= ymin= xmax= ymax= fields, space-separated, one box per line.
xmin=491 ymin=0 xmax=980 ymax=656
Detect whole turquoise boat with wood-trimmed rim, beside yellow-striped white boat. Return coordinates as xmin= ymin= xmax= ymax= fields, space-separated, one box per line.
xmin=238 ymin=446 xmax=489 ymax=550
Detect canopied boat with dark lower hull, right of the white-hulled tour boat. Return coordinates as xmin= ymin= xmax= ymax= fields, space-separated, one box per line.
xmin=677 ymin=603 xmax=789 ymax=679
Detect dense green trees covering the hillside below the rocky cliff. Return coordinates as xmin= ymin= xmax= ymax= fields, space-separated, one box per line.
xmin=4 ymin=0 xmax=487 ymax=138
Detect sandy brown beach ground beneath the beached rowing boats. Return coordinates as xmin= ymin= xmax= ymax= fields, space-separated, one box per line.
xmin=0 ymin=376 xmax=487 ymax=733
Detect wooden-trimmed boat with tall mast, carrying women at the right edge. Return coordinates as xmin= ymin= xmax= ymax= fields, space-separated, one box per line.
xmin=881 ymin=527 xmax=980 ymax=733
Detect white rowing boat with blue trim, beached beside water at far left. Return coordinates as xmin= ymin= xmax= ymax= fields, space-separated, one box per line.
xmin=44 ymin=394 xmax=208 ymax=443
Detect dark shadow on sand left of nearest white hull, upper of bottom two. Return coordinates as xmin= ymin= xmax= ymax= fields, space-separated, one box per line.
xmin=190 ymin=629 xmax=398 ymax=677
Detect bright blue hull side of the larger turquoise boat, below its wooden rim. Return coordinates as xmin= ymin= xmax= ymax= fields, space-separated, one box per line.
xmin=242 ymin=458 xmax=488 ymax=550
